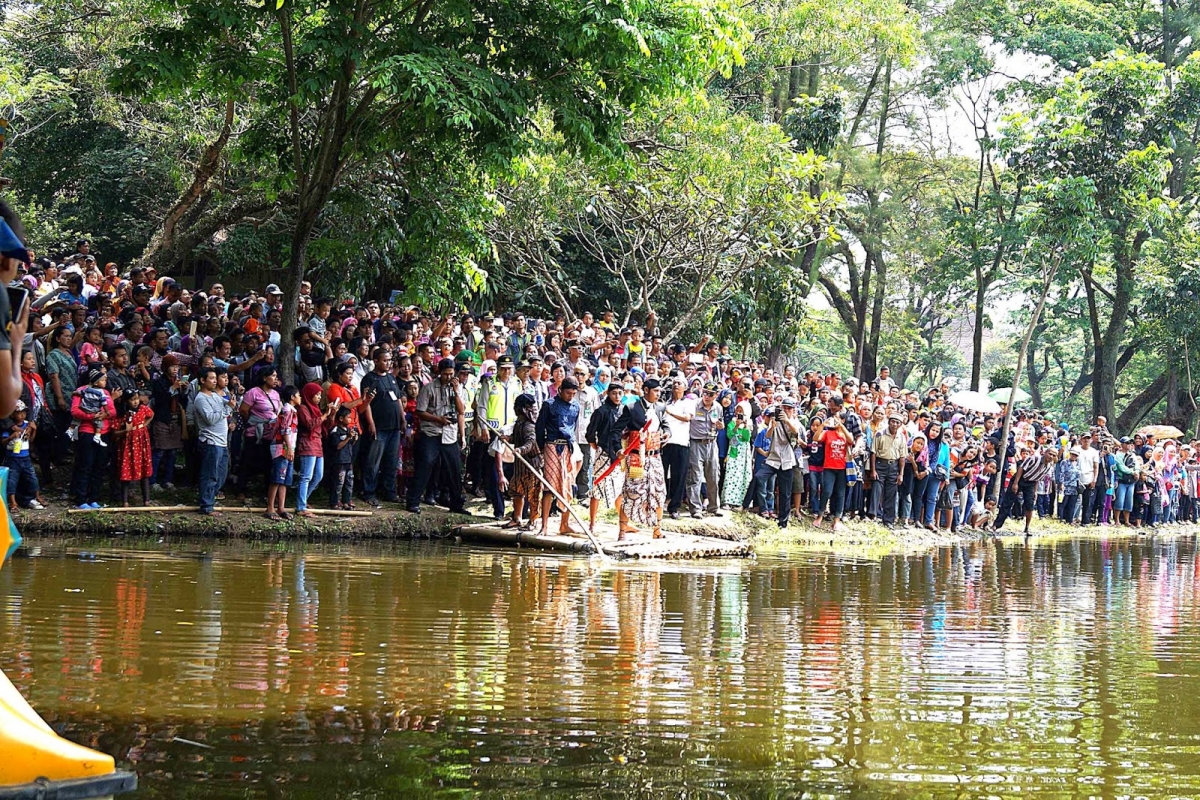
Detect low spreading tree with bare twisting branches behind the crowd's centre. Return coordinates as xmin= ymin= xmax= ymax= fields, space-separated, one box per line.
xmin=492 ymin=98 xmax=838 ymax=338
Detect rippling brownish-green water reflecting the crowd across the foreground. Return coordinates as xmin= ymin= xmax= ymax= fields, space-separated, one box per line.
xmin=0 ymin=539 xmax=1200 ymax=798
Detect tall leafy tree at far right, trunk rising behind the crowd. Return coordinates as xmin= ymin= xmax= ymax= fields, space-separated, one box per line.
xmin=1004 ymin=55 xmax=1200 ymax=420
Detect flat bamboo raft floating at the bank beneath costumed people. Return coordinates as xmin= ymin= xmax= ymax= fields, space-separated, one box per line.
xmin=455 ymin=524 xmax=754 ymax=559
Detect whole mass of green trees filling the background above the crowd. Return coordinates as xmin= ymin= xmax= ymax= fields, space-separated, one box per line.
xmin=7 ymin=0 xmax=1200 ymax=429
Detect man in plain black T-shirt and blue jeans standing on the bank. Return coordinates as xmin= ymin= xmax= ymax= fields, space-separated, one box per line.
xmin=360 ymin=347 xmax=404 ymax=509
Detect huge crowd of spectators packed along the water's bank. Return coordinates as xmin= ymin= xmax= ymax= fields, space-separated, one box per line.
xmin=0 ymin=219 xmax=1200 ymax=536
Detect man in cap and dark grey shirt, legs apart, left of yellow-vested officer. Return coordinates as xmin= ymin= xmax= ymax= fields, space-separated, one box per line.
xmin=406 ymin=359 xmax=467 ymax=513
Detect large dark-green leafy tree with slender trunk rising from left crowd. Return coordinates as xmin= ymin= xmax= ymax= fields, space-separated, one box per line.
xmin=114 ymin=0 xmax=745 ymax=378
